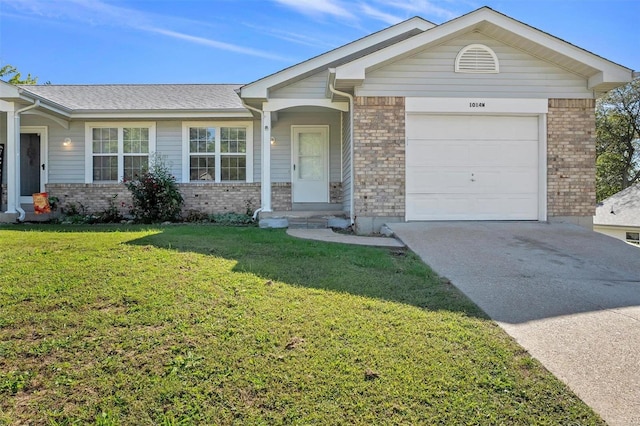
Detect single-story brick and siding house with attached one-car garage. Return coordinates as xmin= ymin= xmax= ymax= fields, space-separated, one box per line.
xmin=0 ymin=7 xmax=632 ymax=233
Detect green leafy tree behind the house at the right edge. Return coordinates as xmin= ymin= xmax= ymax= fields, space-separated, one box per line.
xmin=596 ymin=79 xmax=640 ymax=201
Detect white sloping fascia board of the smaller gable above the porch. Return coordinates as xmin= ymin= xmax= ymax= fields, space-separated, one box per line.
xmin=240 ymin=17 xmax=435 ymax=99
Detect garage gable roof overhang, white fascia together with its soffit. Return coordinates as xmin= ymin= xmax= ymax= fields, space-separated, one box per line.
xmin=335 ymin=6 xmax=632 ymax=92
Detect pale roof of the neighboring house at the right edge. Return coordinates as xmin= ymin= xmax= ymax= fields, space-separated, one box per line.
xmin=593 ymin=183 xmax=640 ymax=227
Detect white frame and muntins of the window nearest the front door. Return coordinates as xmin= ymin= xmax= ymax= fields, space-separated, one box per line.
xmin=182 ymin=121 xmax=254 ymax=185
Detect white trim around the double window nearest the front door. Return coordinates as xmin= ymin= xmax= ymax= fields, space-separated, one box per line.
xmin=182 ymin=121 xmax=253 ymax=184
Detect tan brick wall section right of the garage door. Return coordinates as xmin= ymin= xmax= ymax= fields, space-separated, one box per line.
xmin=547 ymin=99 xmax=596 ymax=217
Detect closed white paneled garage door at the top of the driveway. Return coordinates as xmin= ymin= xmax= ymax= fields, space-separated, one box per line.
xmin=406 ymin=113 xmax=539 ymax=220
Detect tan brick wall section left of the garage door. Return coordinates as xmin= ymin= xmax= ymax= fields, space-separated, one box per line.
xmin=353 ymin=97 xmax=405 ymax=217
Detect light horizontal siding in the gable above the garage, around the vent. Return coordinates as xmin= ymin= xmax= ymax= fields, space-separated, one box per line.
xmin=356 ymin=33 xmax=593 ymax=99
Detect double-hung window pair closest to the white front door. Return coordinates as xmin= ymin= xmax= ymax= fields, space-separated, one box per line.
xmin=182 ymin=122 xmax=253 ymax=183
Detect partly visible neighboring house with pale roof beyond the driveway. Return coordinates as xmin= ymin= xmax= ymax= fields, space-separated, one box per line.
xmin=593 ymin=184 xmax=640 ymax=246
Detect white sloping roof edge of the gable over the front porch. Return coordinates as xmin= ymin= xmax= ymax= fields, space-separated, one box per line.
xmin=240 ymin=16 xmax=436 ymax=99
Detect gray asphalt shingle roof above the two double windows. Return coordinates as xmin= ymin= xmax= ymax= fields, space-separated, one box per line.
xmin=20 ymin=84 xmax=244 ymax=111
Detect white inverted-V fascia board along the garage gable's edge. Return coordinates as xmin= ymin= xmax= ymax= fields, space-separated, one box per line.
xmin=336 ymin=7 xmax=631 ymax=82
